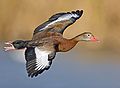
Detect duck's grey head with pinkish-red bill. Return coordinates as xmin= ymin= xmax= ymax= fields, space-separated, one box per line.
xmin=75 ymin=32 xmax=99 ymax=42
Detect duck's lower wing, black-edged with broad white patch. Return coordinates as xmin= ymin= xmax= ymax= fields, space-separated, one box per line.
xmin=25 ymin=47 xmax=56 ymax=77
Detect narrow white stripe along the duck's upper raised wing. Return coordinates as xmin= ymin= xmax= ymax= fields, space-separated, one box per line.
xmin=40 ymin=13 xmax=79 ymax=30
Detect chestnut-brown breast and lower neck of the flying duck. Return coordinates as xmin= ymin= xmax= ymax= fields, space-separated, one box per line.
xmin=59 ymin=38 xmax=79 ymax=52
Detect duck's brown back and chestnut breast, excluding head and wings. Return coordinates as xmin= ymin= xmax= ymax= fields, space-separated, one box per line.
xmin=27 ymin=32 xmax=78 ymax=52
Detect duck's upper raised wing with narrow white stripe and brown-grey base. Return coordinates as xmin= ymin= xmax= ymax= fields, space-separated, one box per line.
xmin=34 ymin=10 xmax=83 ymax=34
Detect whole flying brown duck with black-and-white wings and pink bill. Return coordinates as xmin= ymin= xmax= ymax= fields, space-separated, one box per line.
xmin=5 ymin=10 xmax=97 ymax=77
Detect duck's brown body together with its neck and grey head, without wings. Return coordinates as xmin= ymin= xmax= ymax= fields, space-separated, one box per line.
xmin=27 ymin=32 xmax=96 ymax=52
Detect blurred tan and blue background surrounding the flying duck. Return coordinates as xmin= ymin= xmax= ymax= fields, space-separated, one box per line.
xmin=0 ymin=0 xmax=120 ymax=88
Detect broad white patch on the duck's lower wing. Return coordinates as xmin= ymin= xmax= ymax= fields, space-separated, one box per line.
xmin=35 ymin=47 xmax=50 ymax=70
